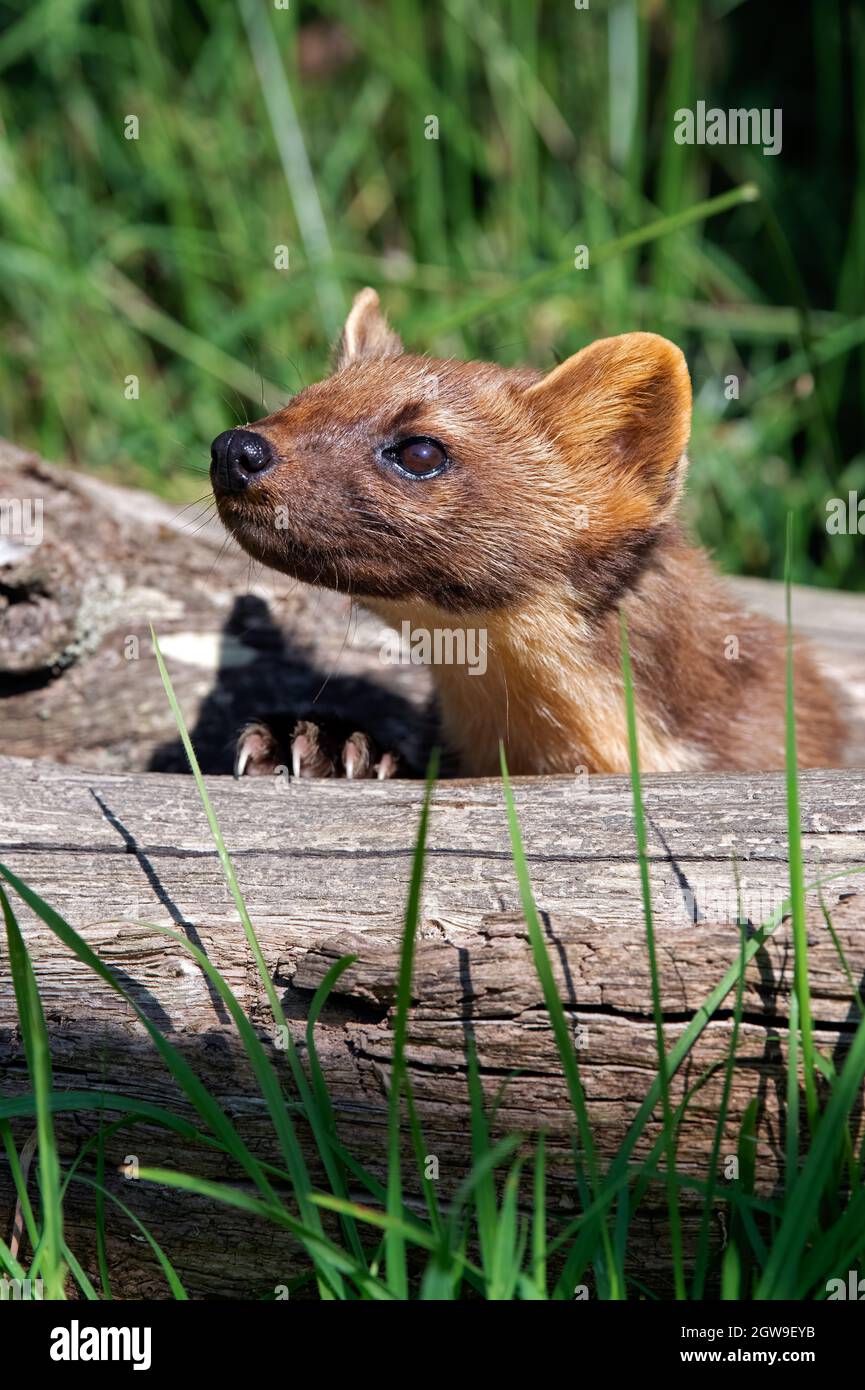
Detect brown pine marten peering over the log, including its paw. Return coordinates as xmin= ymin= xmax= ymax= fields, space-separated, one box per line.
xmin=211 ymin=289 xmax=844 ymax=777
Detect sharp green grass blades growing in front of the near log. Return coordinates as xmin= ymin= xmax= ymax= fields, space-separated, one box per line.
xmin=0 ymin=537 xmax=865 ymax=1301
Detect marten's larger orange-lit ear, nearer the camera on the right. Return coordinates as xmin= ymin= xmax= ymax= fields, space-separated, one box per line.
xmin=524 ymin=334 xmax=691 ymax=525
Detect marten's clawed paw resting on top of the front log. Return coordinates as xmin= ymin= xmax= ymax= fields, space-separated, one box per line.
xmin=234 ymin=719 xmax=399 ymax=780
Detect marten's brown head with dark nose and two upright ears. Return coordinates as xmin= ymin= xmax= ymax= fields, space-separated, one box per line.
xmin=210 ymin=289 xmax=691 ymax=614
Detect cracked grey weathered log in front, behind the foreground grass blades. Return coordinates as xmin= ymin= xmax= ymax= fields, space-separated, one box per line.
xmin=0 ymin=759 xmax=865 ymax=1297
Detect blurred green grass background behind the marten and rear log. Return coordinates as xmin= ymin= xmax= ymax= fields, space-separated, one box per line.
xmin=0 ymin=0 xmax=865 ymax=589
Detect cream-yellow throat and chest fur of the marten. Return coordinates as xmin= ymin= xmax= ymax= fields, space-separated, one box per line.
xmin=359 ymin=594 xmax=700 ymax=777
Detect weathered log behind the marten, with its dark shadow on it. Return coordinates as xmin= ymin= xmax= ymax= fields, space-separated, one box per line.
xmin=0 ymin=441 xmax=865 ymax=773
